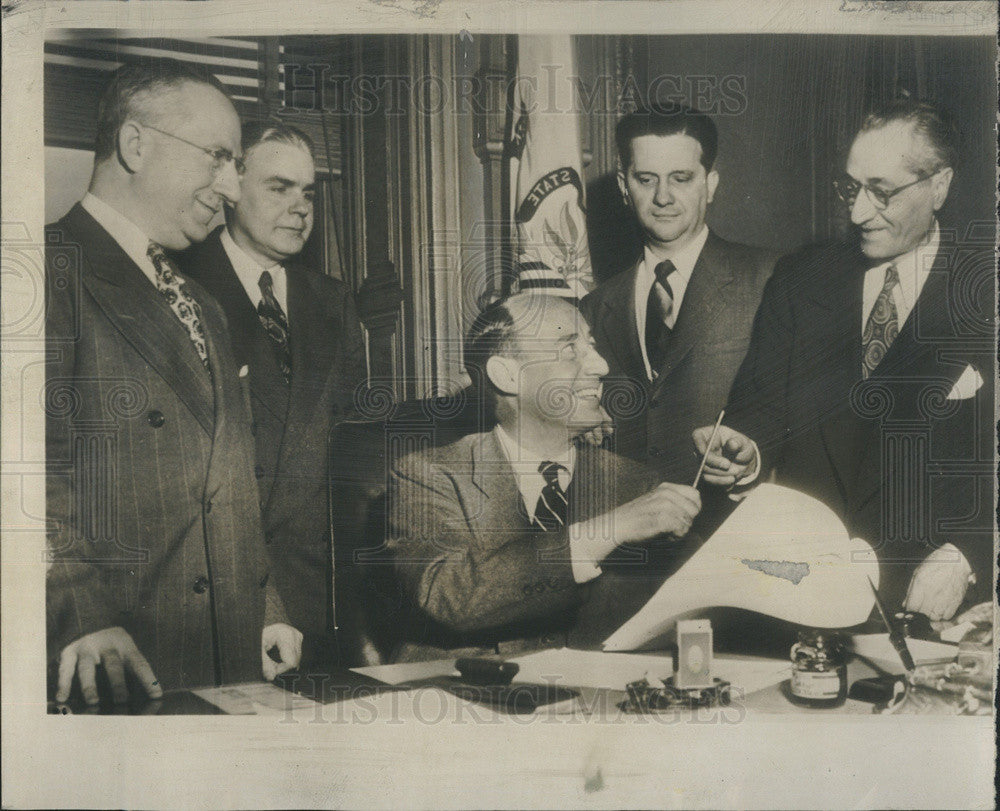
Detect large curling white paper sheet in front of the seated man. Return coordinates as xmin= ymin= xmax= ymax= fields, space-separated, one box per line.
xmin=604 ymin=484 xmax=878 ymax=651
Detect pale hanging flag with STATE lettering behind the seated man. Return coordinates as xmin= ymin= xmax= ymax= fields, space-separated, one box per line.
xmin=507 ymin=36 xmax=594 ymax=299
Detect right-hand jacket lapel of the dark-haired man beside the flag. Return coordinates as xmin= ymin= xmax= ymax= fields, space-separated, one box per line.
xmin=648 ymin=231 xmax=733 ymax=392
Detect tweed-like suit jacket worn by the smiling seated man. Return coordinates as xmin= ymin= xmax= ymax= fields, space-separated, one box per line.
xmin=388 ymin=432 xmax=673 ymax=660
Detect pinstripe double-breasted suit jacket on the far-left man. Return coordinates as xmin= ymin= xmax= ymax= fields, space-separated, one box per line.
xmin=45 ymin=205 xmax=284 ymax=689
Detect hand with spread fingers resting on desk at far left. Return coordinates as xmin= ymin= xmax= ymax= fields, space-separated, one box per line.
xmin=56 ymin=626 xmax=163 ymax=705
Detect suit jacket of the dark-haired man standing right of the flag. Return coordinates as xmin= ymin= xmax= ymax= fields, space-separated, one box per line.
xmin=581 ymin=232 xmax=777 ymax=482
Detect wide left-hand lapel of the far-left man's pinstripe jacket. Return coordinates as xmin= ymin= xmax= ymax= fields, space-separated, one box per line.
xmin=63 ymin=204 xmax=215 ymax=435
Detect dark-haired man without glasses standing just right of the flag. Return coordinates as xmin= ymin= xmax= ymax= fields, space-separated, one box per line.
xmin=582 ymin=107 xmax=776 ymax=481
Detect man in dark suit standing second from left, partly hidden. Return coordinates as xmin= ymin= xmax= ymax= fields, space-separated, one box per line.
xmin=181 ymin=122 xmax=365 ymax=642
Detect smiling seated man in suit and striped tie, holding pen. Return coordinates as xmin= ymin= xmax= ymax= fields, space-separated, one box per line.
xmin=388 ymin=293 xmax=701 ymax=659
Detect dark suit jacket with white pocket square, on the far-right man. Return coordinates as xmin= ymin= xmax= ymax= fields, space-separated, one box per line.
xmin=726 ymin=236 xmax=995 ymax=602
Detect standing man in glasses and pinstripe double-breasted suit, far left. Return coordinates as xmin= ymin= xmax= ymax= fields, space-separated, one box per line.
xmin=45 ymin=60 xmax=301 ymax=704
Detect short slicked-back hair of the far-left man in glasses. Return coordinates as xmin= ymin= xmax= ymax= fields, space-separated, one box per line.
xmin=94 ymin=58 xmax=229 ymax=161
